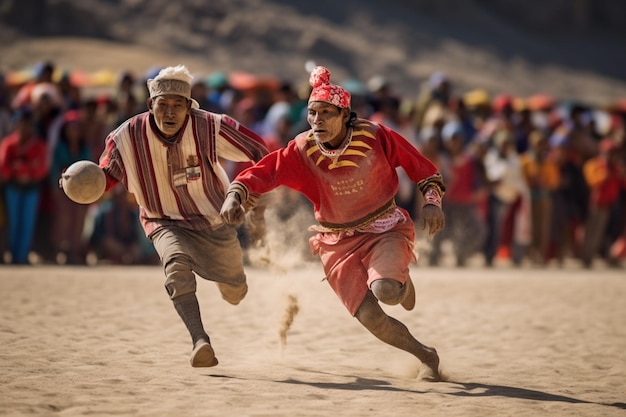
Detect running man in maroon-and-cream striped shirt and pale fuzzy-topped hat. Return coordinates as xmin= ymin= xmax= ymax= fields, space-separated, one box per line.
xmin=100 ymin=65 xmax=268 ymax=367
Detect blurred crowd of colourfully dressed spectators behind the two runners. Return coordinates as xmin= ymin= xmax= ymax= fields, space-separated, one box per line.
xmin=0 ymin=62 xmax=626 ymax=268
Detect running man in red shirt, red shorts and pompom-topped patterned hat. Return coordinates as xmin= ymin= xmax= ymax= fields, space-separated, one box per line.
xmin=221 ymin=67 xmax=444 ymax=379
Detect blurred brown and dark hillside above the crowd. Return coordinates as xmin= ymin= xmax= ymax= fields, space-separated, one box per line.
xmin=0 ymin=0 xmax=626 ymax=103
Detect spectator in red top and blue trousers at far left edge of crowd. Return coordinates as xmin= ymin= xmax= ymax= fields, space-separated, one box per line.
xmin=0 ymin=109 xmax=48 ymax=264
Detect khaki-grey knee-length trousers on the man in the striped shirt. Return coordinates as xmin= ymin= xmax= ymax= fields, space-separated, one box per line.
xmin=150 ymin=225 xmax=248 ymax=304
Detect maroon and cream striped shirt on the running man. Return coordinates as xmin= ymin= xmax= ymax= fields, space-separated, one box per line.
xmin=100 ymin=109 xmax=268 ymax=236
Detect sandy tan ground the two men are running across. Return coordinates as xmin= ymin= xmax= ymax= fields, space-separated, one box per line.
xmin=0 ymin=256 xmax=626 ymax=417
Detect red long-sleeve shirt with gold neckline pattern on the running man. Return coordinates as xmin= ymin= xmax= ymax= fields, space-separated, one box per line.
xmin=234 ymin=119 xmax=440 ymax=226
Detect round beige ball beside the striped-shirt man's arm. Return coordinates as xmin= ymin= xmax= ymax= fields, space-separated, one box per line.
xmin=62 ymin=161 xmax=106 ymax=204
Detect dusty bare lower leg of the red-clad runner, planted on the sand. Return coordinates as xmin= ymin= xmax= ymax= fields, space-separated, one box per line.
xmin=355 ymin=292 xmax=441 ymax=380
